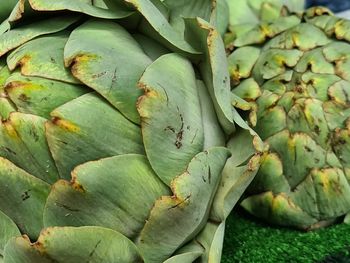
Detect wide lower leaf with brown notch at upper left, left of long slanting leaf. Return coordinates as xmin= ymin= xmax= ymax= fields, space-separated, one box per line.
xmin=44 ymin=154 xmax=170 ymax=238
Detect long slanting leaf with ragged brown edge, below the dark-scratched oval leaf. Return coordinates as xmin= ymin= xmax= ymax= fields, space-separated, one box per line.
xmin=138 ymin=147 xmax=229 ymax=262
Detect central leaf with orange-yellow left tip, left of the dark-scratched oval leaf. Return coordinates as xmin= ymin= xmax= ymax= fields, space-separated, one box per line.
xmin=45 ymin=93 xmax=144 ymax=179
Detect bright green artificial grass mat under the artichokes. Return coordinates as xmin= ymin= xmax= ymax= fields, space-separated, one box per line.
xmin=221 ymin=209 xmax=350 ymax=263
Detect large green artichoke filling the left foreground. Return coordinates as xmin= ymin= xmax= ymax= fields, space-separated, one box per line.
xmin=0 ymin=0 xmax=260 ymax=263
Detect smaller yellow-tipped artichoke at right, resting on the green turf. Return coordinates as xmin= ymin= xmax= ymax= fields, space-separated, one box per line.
xmin=228 ymin=7 xmax=350 ymax=229
